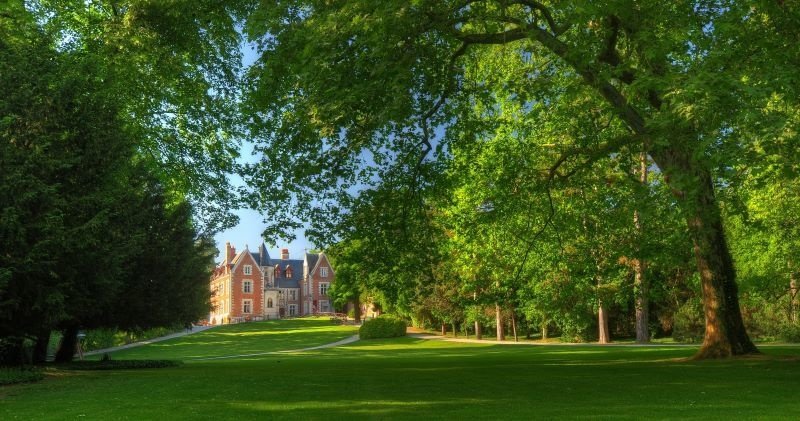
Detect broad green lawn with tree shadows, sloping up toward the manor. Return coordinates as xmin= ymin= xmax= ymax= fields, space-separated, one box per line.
xmin=0 ymin=321 xmax=800 ymax=420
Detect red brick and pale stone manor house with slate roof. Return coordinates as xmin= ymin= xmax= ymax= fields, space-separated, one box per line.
xmin=208 ymin=242 xmax=335 ymax=324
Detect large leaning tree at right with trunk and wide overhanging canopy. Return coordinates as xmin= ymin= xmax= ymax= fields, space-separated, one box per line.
xmin=239 ymin=0 xmax=797 ymax=358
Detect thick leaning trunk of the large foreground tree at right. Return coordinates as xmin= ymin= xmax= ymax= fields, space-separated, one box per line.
xmin=651 ymin=148 xmax=758 ymax=359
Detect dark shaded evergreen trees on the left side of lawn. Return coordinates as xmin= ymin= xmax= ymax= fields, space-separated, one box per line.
xmin=0 ymin=4 xmax=225 ymax=364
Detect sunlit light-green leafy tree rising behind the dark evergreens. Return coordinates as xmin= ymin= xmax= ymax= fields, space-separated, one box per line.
xmin=25 ymin=0 xmax=244 ymax=233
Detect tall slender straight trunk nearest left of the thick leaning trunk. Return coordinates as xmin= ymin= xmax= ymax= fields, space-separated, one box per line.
xmin=633 ymin=152 xmax=650 ymax=344
